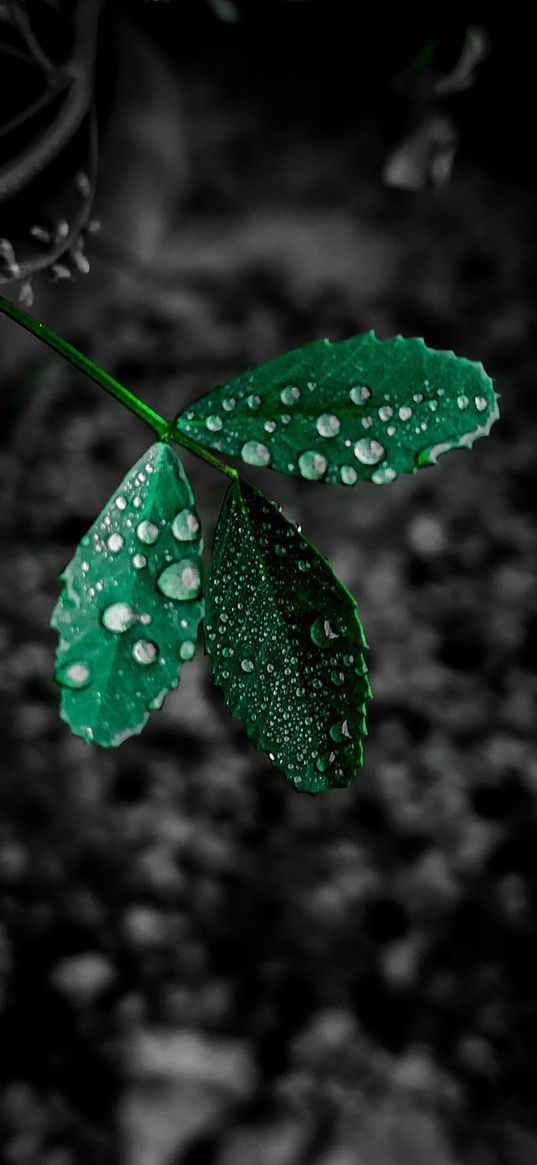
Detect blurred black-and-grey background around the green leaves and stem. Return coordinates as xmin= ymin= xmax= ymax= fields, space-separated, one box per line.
xmin=0 ymin=0 xmax=537 ymax=1165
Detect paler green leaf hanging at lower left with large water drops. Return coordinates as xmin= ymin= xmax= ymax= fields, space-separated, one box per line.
xmin=51 ymin=443 xmax=203 ymax=748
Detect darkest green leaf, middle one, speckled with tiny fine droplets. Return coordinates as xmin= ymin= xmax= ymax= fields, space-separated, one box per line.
xmin=205 ymin=480 xmax=372 ymax=793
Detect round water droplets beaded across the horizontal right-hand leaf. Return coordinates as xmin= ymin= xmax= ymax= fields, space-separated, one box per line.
xmin=185 ymin=381 xmax=487 ymax=486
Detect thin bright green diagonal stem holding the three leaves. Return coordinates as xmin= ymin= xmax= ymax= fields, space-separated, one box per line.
xmin=0 ymin=296 xmax=238 ymax=478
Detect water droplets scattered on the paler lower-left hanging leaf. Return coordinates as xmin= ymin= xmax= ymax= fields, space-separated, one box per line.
xmin=58 ymin=461 xmax=202 ymax=707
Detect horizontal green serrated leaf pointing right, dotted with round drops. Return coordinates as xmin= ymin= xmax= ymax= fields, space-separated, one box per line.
xmin=176 ymin=332 xmax=499 ymax=486
